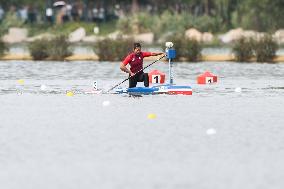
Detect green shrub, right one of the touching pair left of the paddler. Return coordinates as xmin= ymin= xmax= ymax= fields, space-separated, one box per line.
xmin=47 ymin=35 xmax=72 ymax=60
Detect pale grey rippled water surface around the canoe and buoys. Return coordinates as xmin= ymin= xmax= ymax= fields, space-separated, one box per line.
xmin=0 ymin=61 xmax=284 ymax=189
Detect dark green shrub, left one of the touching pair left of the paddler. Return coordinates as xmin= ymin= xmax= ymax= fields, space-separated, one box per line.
xmin=29 ymin=39 xmax=49 ymax=60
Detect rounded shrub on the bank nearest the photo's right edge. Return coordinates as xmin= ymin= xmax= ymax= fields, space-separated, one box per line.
xmin=254 ymin=35 xmax=279 ymax=62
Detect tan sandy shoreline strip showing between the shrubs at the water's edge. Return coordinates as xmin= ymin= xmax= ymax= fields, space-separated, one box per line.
xmin=0 ymin=54 xmax=284 ymax=63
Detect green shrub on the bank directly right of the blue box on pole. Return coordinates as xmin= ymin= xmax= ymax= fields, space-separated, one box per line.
xmin=169 ymin=35 xmax=202 ymax=62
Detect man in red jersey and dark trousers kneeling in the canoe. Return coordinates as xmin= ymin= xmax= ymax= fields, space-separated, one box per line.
xmin=120 ymin=43 xmax=164 ymax=88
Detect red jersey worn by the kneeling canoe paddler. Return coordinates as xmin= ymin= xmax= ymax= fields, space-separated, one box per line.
xmin=122 ymin=52 xmax=152 ymax=73
